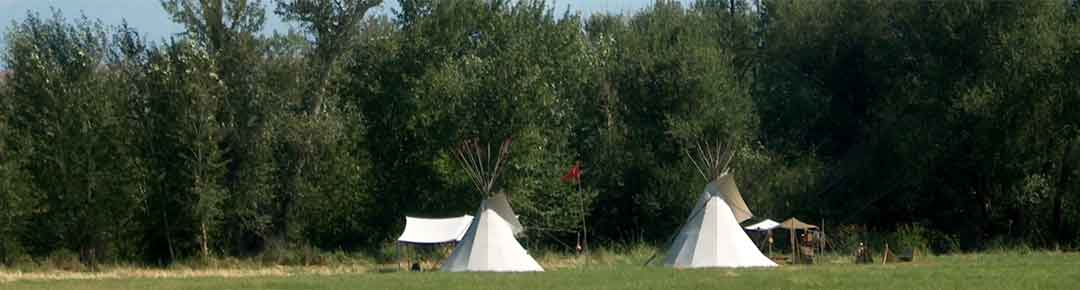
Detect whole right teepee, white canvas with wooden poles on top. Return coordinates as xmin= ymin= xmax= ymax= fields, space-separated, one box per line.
xmin=663 ymin=141 xmax=777 ymax=267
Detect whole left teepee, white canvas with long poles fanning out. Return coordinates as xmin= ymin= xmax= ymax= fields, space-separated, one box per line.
xmin=442 ymin=140 xmax=543 ymax=272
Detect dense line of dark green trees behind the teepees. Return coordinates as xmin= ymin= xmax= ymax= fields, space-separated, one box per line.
xmin=0 ymin=0 xmax=1080 ymax=263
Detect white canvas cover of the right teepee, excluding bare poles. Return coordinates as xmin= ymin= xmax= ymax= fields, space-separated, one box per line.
xmin=663 ymin=178 xmax=777 ymax=267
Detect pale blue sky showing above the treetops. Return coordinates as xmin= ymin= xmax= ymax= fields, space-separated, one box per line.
xmin=0 ymin=0 xmax=689 ymax=42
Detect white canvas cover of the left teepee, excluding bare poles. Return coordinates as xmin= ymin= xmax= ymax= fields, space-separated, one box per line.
xmin=442 ymin=194 xmax=543 ymax=272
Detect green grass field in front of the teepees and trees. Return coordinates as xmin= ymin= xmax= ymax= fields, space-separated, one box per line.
xmin=0 ymin=252 xmax=1080 ymax=290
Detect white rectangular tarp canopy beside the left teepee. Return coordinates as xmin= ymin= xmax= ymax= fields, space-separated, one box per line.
xmin=397 ymin=215 xmax=472 ymax=244
